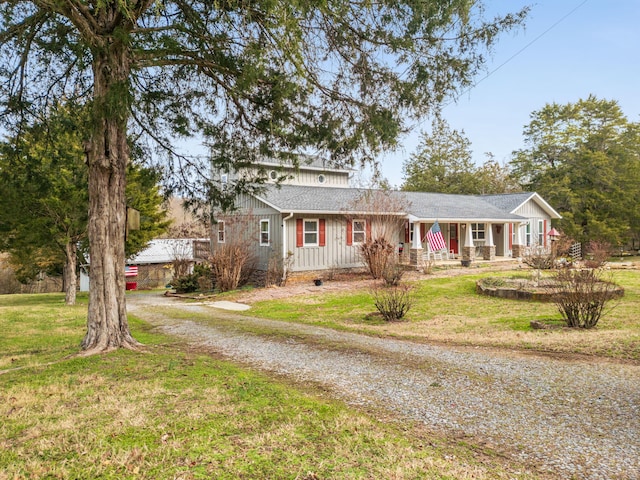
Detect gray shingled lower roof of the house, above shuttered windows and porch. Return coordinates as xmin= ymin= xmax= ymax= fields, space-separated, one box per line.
xmin=258 ymin=185 xmax=523 ymax=222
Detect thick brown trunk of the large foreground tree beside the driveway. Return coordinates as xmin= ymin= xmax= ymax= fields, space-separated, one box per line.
xmin=82 ymin=38 xmax=140 ymax=354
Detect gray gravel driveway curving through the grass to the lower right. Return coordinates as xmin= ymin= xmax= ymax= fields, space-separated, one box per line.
xmin=128 ymin=295 xmax=640 ymax=479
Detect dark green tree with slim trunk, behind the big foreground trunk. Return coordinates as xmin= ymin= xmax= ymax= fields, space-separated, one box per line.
xmin=0 ymin=104 xmax=169 ymax=305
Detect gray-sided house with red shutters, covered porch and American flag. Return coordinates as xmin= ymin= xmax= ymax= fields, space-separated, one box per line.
xmin=212 ymin=159 xmax=560 ymax=272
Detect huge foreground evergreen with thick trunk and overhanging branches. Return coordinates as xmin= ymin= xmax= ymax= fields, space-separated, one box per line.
xmin=0 ymin=0 xmax=527 ymax=353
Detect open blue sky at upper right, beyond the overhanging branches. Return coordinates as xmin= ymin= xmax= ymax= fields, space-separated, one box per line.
xmin=381 ymin=0 xmax=640 ymax=186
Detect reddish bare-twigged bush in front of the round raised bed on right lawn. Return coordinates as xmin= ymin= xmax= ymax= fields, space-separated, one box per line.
xmin=549 ymin=269 xmax=619 ymax=328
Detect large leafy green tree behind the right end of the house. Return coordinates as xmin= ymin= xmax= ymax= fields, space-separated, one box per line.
xmin=511 ymin=95 xmax=640 ymax=245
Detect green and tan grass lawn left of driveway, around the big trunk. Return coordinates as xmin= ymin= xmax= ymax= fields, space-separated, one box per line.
xmin=0 ymin=287 xmax=539 ymax=480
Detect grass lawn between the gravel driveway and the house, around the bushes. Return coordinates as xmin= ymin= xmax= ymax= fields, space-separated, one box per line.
xmin=246 ymin=270 xmax=640 ymax=360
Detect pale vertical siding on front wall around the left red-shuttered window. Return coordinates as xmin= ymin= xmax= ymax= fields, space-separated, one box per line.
xmin=287 ymin=215 xmax=363 ymax=271
